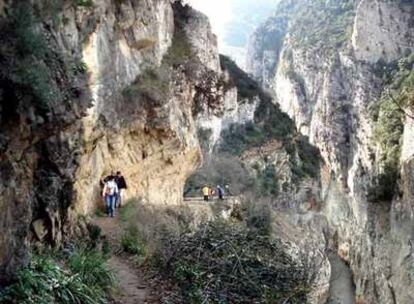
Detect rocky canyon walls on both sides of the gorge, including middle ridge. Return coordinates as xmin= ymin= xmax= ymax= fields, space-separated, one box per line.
xmin=0 ymin=0 xmax=414 ymax=304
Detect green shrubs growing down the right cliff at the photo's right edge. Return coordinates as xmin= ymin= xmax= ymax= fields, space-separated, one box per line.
xmin=368 ymin=55 xmax=414 ymax=202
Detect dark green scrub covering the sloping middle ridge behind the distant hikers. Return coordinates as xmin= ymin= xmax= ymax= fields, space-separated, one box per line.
xmin=189 ymin=56 xmax=321 ymax=196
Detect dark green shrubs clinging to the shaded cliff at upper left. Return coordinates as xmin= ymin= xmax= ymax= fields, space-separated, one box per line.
xmin=0 ymin=0 xmax=87 ymax=113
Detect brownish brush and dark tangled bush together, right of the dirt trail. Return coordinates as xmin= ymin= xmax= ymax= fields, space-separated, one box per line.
xmin=116 ymin=202 xmax=310 ymax=304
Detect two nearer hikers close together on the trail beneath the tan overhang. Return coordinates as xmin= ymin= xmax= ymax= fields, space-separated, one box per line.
xmin=101 ymin=171 xmax=127 ymax=217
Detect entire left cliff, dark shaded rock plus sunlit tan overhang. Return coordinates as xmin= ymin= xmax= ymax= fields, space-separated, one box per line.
xmin=0 ymin=0 xmax=226 ymax=281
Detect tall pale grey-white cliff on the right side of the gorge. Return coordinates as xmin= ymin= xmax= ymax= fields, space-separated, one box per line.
xmin=249 ymin=0 xmax=414 ymax=303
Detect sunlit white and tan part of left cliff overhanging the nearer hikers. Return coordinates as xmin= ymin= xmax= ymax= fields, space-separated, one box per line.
xmin=71 ymin=1 xmax=199 ymax=212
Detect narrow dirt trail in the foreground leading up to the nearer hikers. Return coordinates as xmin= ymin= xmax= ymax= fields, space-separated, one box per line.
xmin=93 ymin=217 xmax=159 ymax=304
